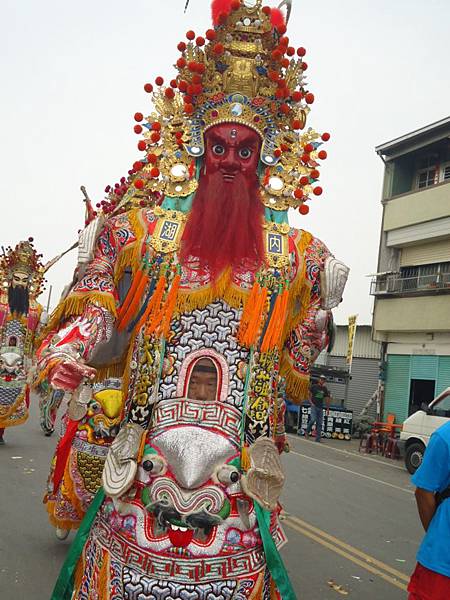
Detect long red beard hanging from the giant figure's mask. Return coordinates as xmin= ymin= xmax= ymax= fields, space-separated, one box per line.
xmin=180 ymin=171 xmax=264 ymax=280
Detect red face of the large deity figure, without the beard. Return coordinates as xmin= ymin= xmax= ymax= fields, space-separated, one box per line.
xmin=204 ymin=123 xmax=261 ymax=183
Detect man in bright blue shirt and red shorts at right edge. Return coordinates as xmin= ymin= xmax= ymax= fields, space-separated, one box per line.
xmin=408 ymin=422 xmax=450 ymax=600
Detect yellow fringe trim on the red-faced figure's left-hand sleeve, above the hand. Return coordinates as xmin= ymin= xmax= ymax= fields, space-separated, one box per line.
xmin=40 ymin=292 xmax=117 ymax=343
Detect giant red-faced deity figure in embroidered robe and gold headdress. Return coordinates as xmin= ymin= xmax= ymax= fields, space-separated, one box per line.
xmin=39 ymin=0 xmax=347 ymax=600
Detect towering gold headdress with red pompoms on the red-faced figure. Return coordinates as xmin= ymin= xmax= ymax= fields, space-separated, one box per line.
xmin=121 ymin=0 xmax=330 ymax=214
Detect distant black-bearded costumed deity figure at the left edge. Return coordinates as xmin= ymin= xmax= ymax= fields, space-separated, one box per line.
xmin=0 ymin=238 xmax=44 ymax=444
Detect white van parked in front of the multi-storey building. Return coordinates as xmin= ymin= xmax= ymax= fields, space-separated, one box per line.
xmin=398 ymin=387 xmax=450 ymax=474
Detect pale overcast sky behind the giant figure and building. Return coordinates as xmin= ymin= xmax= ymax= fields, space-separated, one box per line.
xmin=0 ymin=0 xmax=450 ymax=324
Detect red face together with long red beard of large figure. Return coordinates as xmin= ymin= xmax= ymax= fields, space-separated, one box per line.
xmin=180 ymin=123 xmax=265 ymax=279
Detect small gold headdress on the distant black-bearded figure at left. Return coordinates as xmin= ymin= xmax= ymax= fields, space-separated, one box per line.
xmin=0 ymin=238 xmax=45 ymax=298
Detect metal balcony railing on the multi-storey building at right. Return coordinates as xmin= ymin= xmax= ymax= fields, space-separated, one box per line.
xmin=370 ymin=273 xmax=450 ymax=296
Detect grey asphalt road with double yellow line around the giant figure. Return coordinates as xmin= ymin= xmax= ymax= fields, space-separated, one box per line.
xmin=0 ymin=401 xmax=422 ymax=600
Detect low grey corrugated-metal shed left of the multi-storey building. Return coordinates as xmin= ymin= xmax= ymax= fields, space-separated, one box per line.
xmin=316 ymin=325 xmax=381 ymax=418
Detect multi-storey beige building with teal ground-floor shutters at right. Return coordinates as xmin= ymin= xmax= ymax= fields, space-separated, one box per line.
xmin=371 ymin=117 xmax=450 ymax=422
